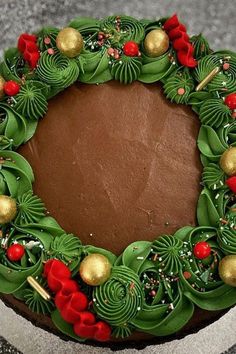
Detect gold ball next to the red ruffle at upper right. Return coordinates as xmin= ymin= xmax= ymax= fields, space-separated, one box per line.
xmin=144 ymin=28 xmax=169 ymax=58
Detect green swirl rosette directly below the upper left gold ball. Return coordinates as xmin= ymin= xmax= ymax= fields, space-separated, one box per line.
xmin=36 ymin=51 xmax=79 ymax=92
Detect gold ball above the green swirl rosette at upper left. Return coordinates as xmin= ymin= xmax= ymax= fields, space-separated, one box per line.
xmin=56 ymin=27 xmax=84 ymax=58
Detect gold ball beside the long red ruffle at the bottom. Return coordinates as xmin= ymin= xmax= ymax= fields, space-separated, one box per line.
xmin=79 ymin=253 xmax=111 ymax=286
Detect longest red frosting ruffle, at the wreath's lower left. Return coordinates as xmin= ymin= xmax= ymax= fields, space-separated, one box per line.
xmin=43 ymin=259 xmax=111 ymax=342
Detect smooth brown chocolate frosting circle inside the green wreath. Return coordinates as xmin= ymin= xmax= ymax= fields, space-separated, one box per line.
xmin=19 ymin=81 xmax=201 ymax=254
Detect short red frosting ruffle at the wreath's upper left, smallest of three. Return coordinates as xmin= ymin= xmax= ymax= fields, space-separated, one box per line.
xmin=18 ymin=33 xmax=40 ymax=69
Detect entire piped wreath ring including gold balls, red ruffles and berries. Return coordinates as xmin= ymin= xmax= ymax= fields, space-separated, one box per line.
xmin=0 ymin=15 xmax=236 ymax=341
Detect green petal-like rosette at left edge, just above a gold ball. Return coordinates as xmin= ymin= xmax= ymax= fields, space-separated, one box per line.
xmin=0 ymin=150 xmax=34 ymax=197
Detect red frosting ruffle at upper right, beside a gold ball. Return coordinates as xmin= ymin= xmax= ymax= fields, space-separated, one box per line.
xmin=163 ymin=14 xmax=197 ymax=68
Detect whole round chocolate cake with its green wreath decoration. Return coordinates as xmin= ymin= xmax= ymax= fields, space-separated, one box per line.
xmin=0 ymin=11 xmax=236 ymax=347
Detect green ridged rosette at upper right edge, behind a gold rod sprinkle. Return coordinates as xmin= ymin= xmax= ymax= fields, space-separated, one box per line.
xmin=194 ymin=51 xmax=236 ymax=94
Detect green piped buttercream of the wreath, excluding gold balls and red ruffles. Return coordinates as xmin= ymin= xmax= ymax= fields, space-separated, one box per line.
xmin=0 ymin=16 xmax=236 ymax=340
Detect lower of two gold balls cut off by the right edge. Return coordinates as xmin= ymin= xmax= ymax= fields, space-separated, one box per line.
xmin=219 ymin=254 xmax=236 ymax=287
